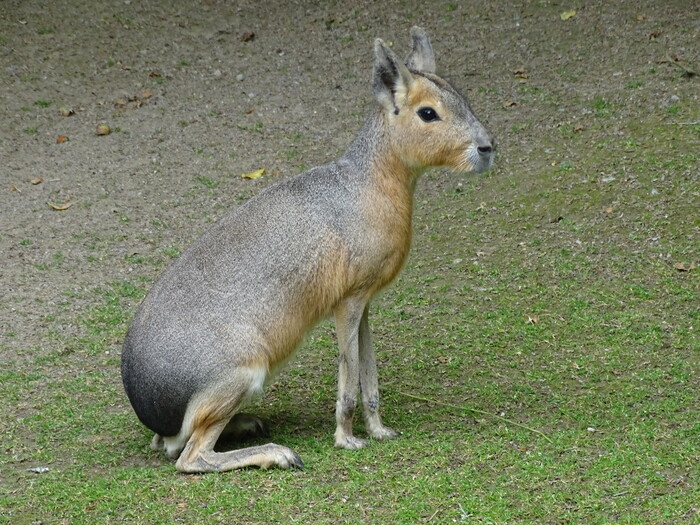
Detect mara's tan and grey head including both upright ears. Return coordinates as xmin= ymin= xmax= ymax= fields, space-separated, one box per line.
xmin=373 ymin=27 xmax=494 ymax=173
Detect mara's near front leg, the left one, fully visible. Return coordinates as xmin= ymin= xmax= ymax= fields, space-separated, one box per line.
xmin=334 ymin=297 xmax=367 ymax=450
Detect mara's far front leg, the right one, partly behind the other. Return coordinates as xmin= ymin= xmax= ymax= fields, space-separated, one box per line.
xmin=359 ymin=303 xmax=398 ymax=439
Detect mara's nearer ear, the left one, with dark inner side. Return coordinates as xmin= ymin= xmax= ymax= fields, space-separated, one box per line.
xmin=373 ymin=38 xmax=413 ymax=115
